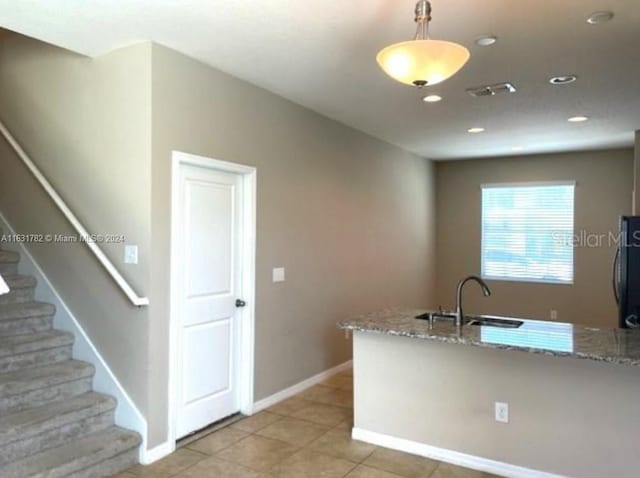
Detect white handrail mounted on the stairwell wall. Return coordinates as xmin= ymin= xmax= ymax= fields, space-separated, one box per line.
xmin=0 ymin=121 xmax=149 ymax=307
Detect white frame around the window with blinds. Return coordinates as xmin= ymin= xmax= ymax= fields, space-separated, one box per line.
xmin=480 ymin=180 xmax=578 ymax=286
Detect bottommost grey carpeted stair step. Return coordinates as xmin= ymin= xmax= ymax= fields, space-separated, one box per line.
xmin=2 ymin=426 xmax=141 ymax=478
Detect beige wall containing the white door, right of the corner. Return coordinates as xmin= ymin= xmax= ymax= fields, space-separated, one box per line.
xmin=150 ymin=45 xmax=434 ymax=441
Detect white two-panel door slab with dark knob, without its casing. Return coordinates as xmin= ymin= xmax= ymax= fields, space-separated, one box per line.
xmin=176 ymin=164 xmax=243 ymax=438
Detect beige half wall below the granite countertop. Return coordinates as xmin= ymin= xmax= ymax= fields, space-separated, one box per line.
xmin=354 ymin=332 xmax=640 ymax=478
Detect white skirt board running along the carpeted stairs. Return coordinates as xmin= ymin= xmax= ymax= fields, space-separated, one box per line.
xmin=0 ymin=213 xmax=148 ymax=463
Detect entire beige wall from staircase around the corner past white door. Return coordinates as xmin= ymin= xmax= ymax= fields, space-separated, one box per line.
xmin=0 ymin=34 xmax=435 ymax=447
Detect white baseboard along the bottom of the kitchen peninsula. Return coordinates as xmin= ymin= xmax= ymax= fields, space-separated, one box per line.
xmin=351 ymin=428 xmax=567 ymax=478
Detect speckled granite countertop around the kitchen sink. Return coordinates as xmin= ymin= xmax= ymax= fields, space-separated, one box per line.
xmin=338 ymin=308 xmax=640 ymax=366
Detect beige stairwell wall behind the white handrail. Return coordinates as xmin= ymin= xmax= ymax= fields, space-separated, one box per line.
xmin=0 ymin=34 xmax=151 ymax=413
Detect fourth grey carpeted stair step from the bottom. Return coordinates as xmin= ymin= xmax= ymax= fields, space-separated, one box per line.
xmin=0 ymin=330 xmax=73 ymax=373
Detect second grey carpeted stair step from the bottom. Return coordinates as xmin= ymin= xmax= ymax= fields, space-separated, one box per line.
xmin=0 ymin=392 xmax=116 ymax=467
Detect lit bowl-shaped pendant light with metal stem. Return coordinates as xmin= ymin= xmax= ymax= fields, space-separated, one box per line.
xmin=376 ymin=0 xmax=471 ymax=87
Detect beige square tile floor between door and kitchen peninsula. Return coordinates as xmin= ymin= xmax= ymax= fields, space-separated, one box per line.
xmin=116 ymin=372 xmax=497 ymax=478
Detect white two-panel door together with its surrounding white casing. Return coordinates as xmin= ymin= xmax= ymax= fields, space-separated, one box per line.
xmin=169 ymin=152 xmax=255 ymax=448
